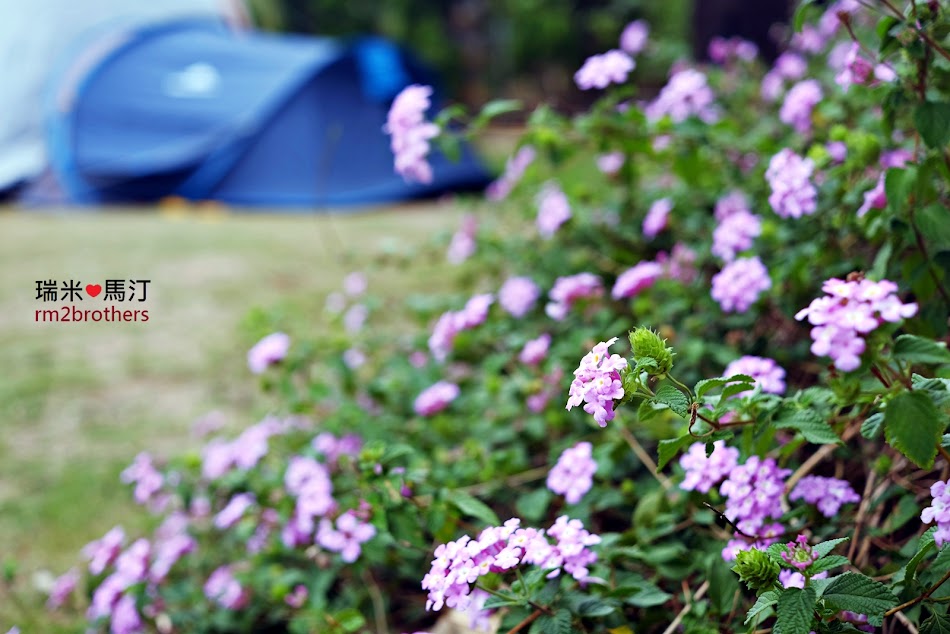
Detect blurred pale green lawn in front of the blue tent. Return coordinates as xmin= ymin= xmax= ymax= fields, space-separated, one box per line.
xmin=0 ymin=204 xmax=468 ymax=632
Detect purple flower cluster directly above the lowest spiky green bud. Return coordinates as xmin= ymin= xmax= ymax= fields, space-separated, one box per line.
xmin=719 ymin=456 xmax=792 ymax=559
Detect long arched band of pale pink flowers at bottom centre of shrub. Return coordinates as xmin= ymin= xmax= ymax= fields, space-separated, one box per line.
xmin=422 ymin=515 xmax=600 ymax=611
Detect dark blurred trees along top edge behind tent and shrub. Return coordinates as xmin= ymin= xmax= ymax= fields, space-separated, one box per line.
xmin=248 ymin=0 xmax=752 ymax=109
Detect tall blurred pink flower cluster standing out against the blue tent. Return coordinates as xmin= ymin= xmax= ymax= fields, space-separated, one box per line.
xmin=383 ymin=84 xmax=439 ymax=183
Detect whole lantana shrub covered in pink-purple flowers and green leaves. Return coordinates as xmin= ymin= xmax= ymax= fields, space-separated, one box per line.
xmin=33 ymin=0 xmax=950 ymax=634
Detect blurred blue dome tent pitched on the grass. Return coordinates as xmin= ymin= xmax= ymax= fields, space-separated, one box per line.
xmin=47 ymin=21 xmax=487 ymax=207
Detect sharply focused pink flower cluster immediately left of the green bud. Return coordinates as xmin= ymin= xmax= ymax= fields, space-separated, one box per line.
xmin=567 ymin=337 xmax=627 ymax=427
